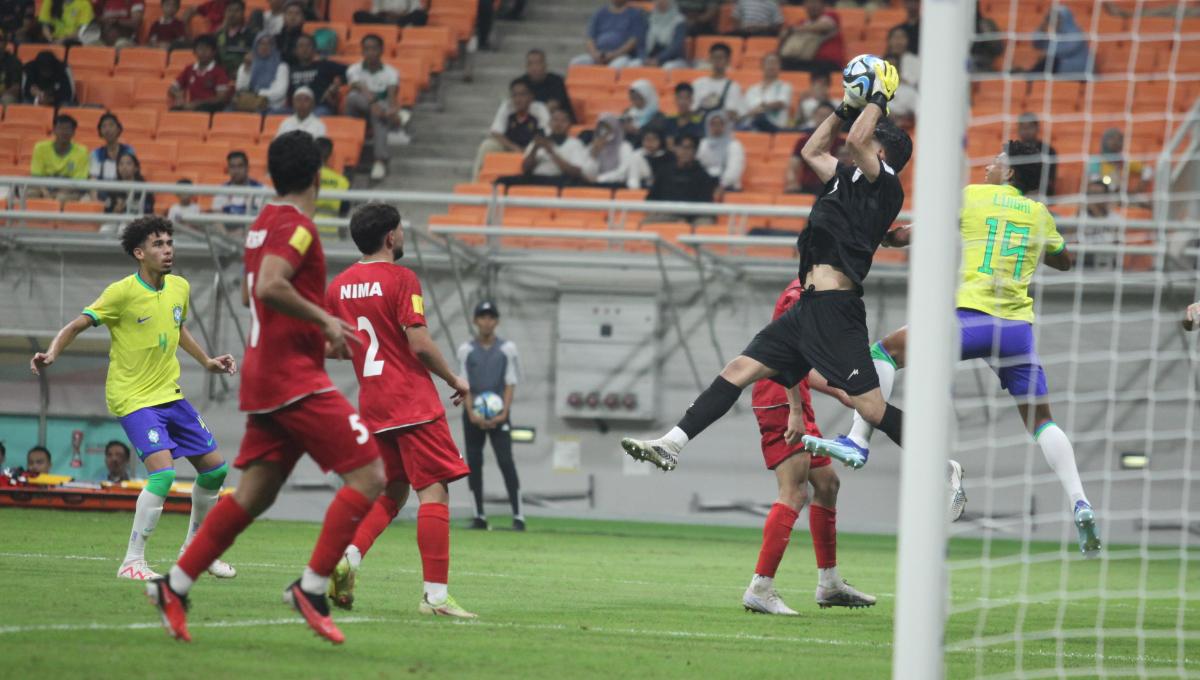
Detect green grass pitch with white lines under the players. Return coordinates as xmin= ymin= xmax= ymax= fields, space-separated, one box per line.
xmin=0 ymin=509 xmax=1200 ymax=680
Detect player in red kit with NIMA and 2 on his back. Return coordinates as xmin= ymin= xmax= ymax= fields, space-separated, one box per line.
xmin=325 ymin=203 xmax=475 ymax=619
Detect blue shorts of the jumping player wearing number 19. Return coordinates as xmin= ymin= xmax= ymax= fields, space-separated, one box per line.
xmin=958 ymin=309 xmax=1048 ymax=398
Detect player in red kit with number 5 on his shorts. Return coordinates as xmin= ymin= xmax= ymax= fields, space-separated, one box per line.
xmin=146 ymin=131 xmax=384 ymax=644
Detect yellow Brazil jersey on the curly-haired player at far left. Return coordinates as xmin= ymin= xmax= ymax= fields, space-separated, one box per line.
xmin=83 ymin=273 xmax=191 ymax=417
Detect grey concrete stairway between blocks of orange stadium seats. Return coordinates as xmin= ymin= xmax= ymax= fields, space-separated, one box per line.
xmin=383 ymin=0 xmax=596 ymax=207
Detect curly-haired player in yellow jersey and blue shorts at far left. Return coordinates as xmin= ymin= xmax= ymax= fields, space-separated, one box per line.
xmin=30 ymin=217 xmax=238 ymax=580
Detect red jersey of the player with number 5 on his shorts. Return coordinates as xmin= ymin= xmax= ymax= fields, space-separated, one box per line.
xmin=240 ymin=203 xmax=334 ymax=413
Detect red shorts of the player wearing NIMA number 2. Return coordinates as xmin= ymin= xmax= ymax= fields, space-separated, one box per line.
xmin=374 ymin=415 xmax=470 ymax=489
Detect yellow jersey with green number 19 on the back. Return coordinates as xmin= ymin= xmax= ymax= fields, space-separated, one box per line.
xmin=958 ymin=185 xmax=1066 ymax=323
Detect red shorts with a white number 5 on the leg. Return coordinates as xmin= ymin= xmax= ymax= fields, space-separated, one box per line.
xmin=234 ymin=390 xmax=379 ymax=474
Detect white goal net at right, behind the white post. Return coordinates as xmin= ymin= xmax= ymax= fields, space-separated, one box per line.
xmin=894 ymin=0 xmax=1200 ymax=678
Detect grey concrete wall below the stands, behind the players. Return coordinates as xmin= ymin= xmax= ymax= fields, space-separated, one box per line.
xmin=0 ymin=241 xmax=1200 ymax=543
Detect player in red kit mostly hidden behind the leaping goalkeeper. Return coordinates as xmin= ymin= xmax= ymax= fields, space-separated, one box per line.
xmin=742 ymin=279 xmax=875 ymax=616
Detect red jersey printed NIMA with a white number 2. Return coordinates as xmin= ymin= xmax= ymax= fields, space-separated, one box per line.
xmin=325 ymin=261 xmax=445 ymax=432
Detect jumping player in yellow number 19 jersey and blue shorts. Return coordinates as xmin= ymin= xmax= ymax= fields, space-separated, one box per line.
xmin=816 ymin=140 xmax=1100 ymax=556
